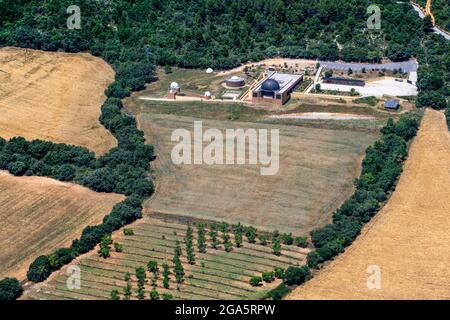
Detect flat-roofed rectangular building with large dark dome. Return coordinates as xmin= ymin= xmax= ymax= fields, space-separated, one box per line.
xmin=252 ymin=72 xmax=303 ymax=106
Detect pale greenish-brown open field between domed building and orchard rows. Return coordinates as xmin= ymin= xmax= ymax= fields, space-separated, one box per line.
xmin=125 ymin=102 xmax=377 ymax=235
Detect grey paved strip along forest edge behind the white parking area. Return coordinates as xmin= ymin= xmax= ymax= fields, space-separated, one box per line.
xmin=320 ymin=60 xmax=418 ymax=73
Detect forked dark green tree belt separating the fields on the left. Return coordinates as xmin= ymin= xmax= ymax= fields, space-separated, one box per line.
xmin=2 ymin=43 xmax=154 ymax=288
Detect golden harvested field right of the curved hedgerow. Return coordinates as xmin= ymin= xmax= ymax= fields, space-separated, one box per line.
xmin=289 ymin=110 xmax=450 ymax=300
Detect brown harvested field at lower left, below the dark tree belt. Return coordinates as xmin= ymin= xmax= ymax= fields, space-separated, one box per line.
xmin=0 ymin=171 xmax=124 ymax=280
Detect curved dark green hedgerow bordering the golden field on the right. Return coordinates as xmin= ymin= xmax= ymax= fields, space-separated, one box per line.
xmin=307 ymin=112 xmax=421 ymax=269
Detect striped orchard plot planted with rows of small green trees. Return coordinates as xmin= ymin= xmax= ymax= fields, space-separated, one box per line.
xmin=23 ymin=215 xmax=309 ymax=300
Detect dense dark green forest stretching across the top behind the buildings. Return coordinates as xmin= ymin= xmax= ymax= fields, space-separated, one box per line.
xmin=0 ymin=0 xmax=450 ymax=108
